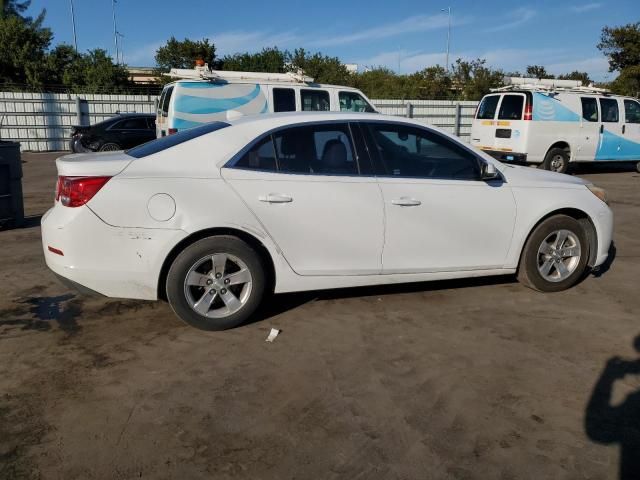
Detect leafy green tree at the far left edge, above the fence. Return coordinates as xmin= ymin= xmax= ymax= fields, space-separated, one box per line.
xmin=0 ymin=10 xmax=53 ymax=88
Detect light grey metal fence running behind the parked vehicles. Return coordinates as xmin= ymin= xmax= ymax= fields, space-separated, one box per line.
xmin=0 ymin=92 xmax=477 ymax=151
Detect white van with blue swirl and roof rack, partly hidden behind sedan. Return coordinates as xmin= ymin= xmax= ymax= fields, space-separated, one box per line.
xmin=156 ymin=65 xmax=376 ymax=137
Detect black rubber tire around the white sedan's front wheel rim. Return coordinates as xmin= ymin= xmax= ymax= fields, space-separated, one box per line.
xmin=518 ymin=215 xmax=590 ymax=292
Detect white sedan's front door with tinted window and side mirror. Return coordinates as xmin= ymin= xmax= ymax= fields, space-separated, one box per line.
xmin=364 ymin=122 xmax=516 ymax=273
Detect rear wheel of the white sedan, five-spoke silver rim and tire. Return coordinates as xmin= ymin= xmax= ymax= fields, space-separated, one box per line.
xmin=166 ymin=236 xmax=266 ymax=330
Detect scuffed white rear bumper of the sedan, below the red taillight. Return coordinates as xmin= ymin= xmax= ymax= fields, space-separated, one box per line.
xmin=42 ymin=205 xmax=186 ymax=300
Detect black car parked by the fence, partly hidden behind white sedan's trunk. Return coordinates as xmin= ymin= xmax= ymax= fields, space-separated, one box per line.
xmin=70 ymin=113 xmax=156 ymax=153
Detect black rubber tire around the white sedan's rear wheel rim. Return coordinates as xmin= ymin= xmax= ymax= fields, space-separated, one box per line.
xmin=166 ymin=235 xmax=266 ymax=331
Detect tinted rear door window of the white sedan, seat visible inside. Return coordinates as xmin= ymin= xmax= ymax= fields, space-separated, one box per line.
xmin=273 ymin=123 xmax=358 ymax=175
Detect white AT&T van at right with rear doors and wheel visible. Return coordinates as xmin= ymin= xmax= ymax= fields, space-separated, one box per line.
xmin=471 ymin=78 xmax=640 ymax=172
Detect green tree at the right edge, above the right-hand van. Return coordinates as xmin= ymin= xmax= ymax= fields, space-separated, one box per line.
xmin=598 ymin=22 xmax=640 ymax=72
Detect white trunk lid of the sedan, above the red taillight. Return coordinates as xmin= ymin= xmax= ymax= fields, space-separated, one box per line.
xmin=56 ymin=152 xmax=134 ymax=177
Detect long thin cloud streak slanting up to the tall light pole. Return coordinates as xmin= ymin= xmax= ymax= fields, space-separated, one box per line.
xmin=307 ymin=14 xmax=469 ymax=47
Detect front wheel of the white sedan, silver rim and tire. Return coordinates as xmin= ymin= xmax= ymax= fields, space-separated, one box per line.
xmin=518 ymin=215 xmax=589 ymax=292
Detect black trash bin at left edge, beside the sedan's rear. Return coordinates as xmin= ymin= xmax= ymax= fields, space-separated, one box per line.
xmin=0 ymin=141 xmax=24 ymax=227
